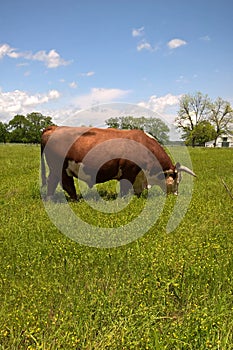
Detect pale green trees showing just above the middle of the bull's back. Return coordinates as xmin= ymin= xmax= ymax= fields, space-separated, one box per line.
xmin=105 ymin=116 xmax=169 ymax=143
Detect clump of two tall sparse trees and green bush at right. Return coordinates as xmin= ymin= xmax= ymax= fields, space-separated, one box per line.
xmin=176 ymin=92 xmax=233 ymax=147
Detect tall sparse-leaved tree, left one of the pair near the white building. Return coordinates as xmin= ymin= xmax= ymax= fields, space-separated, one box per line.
xmin=176 ymin=92 xmax=210 ymax=147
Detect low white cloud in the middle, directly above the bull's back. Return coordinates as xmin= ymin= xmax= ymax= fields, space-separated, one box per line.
xmin=74 ymin=88 xmax=131 ymax=108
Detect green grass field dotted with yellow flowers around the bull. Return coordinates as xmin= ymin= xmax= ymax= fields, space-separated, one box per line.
xmin=0 ymin=145 xmax=233 ymax=350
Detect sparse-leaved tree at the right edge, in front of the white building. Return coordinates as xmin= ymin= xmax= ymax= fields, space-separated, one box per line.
xmin=210 ymin=97 xmax=233 ymax=147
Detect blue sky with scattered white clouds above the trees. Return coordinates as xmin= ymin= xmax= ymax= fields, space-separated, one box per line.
xmin=0 ymin=0 xmax=233 ymax=129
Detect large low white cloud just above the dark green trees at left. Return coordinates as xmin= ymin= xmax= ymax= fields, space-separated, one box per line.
xmin=0 ymin=90 xmax=60 ymax=119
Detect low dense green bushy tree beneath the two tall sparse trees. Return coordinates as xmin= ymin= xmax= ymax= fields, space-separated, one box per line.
xmin=185 ymin=120 xmax=216 ymax=146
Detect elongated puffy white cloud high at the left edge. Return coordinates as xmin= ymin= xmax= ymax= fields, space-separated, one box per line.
xmin=0 ymin=44 xmax=71 ymax=68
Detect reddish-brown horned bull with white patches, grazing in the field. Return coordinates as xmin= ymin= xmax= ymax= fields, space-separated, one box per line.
xmin=41 ymin=126 xmax=196 ymax=200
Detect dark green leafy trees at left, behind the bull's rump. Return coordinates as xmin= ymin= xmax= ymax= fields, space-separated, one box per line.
xmin=0 ymin=112 xmax=53 ymax=143
